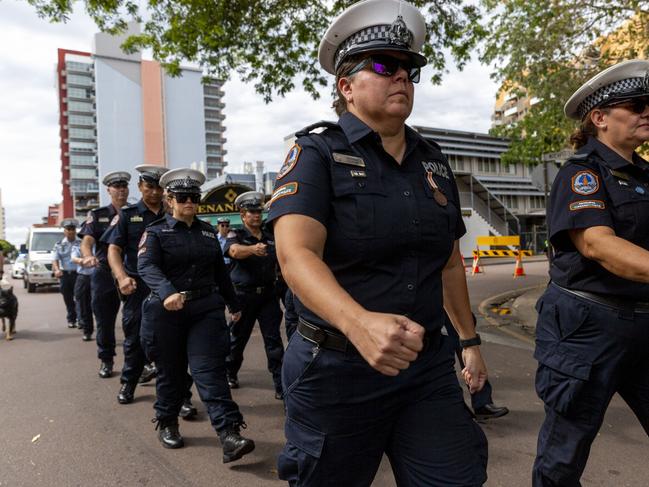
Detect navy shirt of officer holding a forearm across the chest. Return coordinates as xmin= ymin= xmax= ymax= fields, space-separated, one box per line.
xmin=223 ymin=226 xmax=277 ymax=291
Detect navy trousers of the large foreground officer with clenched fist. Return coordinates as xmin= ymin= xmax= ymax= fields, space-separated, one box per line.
xmin=278 ymin=333 xmax=487 ymax=487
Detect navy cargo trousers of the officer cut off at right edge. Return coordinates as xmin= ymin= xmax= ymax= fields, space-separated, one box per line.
xmin=533 ymin=284 xmax=649 ymax=487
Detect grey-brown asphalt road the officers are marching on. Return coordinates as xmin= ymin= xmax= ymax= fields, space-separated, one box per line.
xmin=0 ymin=262 xmax=649 ymax=487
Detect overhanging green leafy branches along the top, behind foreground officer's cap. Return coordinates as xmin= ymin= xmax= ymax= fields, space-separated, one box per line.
xmin=27 ymin=0 xmax=484 ymax=102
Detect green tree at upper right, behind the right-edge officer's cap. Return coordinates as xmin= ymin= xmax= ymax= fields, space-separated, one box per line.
xmin=481 ymin=0 xmax=649 ymax=163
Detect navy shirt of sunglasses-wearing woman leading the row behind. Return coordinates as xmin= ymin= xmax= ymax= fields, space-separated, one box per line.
xmin=137 ymin=215 xmax=239 ymax=313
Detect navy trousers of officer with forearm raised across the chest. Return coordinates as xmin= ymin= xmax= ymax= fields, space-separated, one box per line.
xmin=227 ymin=290 xmax=284 ymax=392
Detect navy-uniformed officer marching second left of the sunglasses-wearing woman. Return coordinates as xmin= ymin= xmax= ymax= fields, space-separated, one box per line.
xmin=79 ymin=171 xmax=131 ymax=379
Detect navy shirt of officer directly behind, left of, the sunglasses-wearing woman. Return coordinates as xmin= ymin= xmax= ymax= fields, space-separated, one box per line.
xmin=101 ymin=200 xmax=165 ymax=277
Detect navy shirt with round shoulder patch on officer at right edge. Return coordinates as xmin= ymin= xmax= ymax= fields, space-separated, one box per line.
xmin=548 ymin=137 xmax=649 ymax=301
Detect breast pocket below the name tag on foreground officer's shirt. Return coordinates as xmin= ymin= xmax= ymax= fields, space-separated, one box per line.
xmin=333 ymin=168 xmax=390 ymax=239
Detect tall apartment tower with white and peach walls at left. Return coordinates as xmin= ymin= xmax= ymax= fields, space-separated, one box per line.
xmin=57 ymin=25 xmax=227 ymax=218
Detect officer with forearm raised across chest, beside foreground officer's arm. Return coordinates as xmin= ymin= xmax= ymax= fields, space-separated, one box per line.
xmin=225 ymin=191 xmax=284 ymax=399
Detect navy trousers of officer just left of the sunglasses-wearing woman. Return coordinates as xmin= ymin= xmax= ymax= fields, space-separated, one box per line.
xmin=120 ymin=278 xmax=150 ymax=384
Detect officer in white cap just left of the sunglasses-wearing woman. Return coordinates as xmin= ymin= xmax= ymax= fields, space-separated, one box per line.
xmin=101 ymin=164 xmax=167 ymax=404
